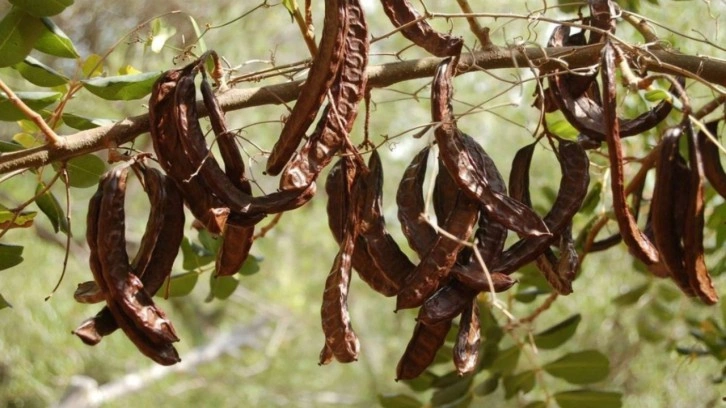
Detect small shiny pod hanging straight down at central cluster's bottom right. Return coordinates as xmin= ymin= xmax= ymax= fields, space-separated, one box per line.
xmin=453 ymin=299 xmax=481 ymax=375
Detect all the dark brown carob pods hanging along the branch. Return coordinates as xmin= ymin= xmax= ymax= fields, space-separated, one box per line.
xmin=69 ymin=0 xmax=726 ymax=379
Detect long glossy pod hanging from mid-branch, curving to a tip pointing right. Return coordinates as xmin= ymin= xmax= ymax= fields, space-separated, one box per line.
xmin=431 ymin=58 xmax=550 ymax=236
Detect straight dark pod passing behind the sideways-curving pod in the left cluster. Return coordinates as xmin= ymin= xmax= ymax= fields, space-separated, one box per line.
xmin=200 ymin=75 xmax=255 ymax=276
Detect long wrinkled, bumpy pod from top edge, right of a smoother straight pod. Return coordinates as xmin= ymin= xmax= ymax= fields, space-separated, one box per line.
xmin=278 ymin=0 xmax=370 ymax=190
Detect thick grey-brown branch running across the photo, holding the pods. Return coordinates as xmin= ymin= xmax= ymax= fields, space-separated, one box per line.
xmin=0 ymin=45 xmax=726 ymax=174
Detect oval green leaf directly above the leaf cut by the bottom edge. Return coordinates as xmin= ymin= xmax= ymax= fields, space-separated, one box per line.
xmin=542 ymin=350 xmax=610 ymax=384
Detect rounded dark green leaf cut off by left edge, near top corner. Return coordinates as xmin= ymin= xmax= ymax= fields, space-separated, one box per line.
xmin=0 ymin=7 xmax=43 ymax=67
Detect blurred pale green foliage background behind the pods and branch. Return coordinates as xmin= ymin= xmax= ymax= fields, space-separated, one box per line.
xmin=0 ymin=0 xmax=726 ymax=407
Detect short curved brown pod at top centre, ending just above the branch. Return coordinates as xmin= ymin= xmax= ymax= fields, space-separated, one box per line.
xmin=381 ymin=0 xmax=464 ymax=57
